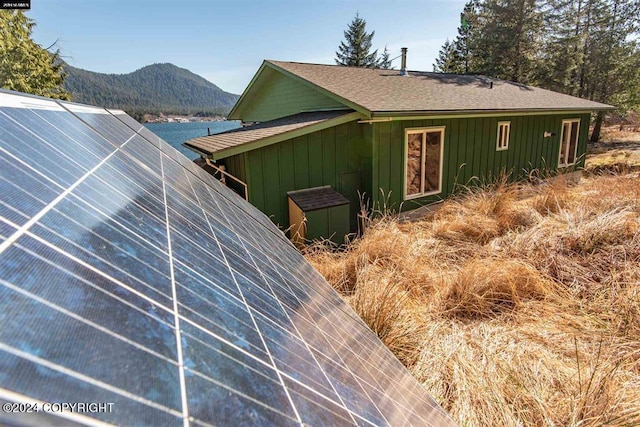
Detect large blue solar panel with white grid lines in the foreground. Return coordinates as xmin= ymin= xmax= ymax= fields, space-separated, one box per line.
xmin=0 ymin=91 xmax=453 ymax=426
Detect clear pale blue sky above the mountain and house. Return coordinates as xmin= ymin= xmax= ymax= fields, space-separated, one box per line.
xmin=27 ymin=0 xmax=465 ymax=94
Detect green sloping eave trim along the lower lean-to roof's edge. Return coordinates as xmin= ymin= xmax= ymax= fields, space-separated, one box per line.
xmin=182 ymin=111 xmax=364 ymax=160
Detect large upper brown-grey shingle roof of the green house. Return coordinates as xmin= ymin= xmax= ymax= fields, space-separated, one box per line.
xmin=266 ymin=61 xmax=613 ymax=113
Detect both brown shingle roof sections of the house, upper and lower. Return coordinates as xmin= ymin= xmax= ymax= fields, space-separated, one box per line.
xmin=183 ymin=61 xmax=614 ymax=154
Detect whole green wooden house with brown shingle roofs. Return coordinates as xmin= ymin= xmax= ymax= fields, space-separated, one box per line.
xmin=184 ymin=61 xmax=613 ymax=242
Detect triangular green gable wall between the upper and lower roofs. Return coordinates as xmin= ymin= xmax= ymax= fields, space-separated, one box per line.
xmin=239 ymin=70 xmax=346 ymax=122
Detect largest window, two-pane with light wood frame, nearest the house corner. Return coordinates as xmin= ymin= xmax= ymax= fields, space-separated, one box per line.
xmin=404 ymin=127 xmax=444 ymax=199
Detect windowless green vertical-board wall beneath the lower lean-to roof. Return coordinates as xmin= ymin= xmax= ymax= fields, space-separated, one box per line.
xmin=222 ymin=121 xmax=371 ymax=230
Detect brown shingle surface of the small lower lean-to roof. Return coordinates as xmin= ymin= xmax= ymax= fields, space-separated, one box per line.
xmin=183 ymin=110 xmax=353 ymax=154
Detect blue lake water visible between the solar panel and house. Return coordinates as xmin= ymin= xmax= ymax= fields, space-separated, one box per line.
xmin=145 ymin=120 xmax=240 ymax=160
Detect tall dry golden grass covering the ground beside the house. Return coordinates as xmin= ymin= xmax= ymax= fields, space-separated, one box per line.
xmin=307 ymin=174 xmax=640 ymax=426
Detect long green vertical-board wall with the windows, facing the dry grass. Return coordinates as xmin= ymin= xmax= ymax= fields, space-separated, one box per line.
xmin=369 ymin=114 xmax=590 ymax=211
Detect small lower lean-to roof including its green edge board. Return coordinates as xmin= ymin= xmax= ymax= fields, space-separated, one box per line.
xmin=183 ymin=110 xmax=361 ymax=158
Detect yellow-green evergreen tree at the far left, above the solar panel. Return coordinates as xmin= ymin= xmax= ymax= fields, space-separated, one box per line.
xmin=0 ymin=10 xmax=71 ymax=99
